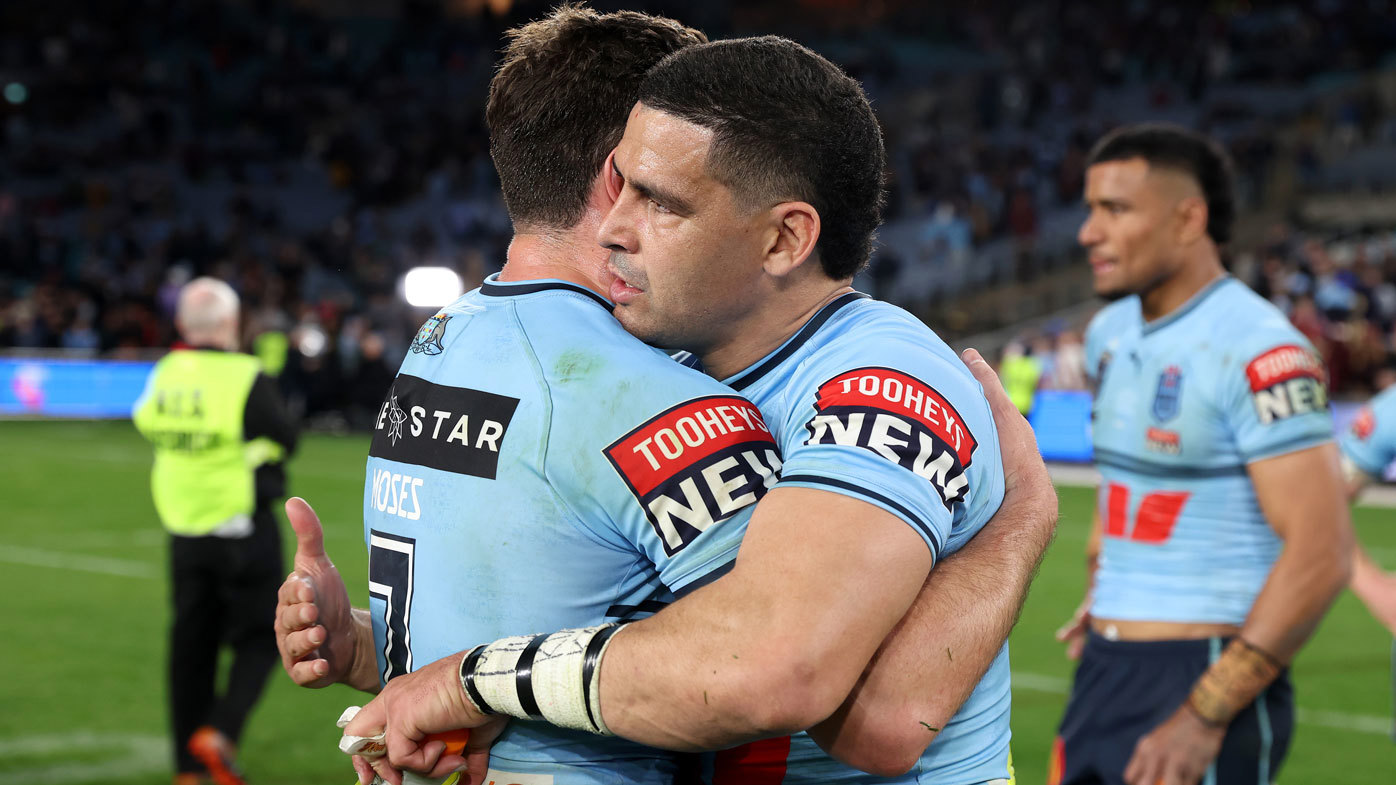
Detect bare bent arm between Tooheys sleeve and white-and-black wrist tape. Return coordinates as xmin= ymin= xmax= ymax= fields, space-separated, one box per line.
xmin=600 ymin=487 xmax=930 ymax=750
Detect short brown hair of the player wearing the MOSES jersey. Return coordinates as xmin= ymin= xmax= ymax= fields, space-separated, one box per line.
xmin=484 ymin=3 xmax=708 ymax=230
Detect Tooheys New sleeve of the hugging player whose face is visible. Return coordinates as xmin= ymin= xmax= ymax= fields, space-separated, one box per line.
xmin=780 ymin=342 xmax=1004 ymax=559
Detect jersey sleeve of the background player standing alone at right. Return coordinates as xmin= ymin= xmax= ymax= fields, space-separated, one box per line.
xmin=1220 ymin=325 xmax=1333 ymax=464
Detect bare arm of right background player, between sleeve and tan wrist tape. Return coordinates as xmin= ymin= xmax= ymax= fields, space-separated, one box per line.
xmin=1241 ymin=444 xmax=1354 ymax=663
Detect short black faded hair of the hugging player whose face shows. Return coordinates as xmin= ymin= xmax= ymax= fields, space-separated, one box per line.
xmin=639 ymin=36 xmax=885 ymax=279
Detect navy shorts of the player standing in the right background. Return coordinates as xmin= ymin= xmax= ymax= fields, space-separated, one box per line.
xmin=1047 ymin=633 xmax=1294 ymax=785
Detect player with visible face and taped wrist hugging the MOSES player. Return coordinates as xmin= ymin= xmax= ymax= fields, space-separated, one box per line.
xmin=346 ymin=38 xmax=1049 ymax=784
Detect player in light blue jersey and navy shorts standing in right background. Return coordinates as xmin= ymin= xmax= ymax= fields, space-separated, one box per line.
xmin=1048 ymin=126 xmax=1353 ymax=785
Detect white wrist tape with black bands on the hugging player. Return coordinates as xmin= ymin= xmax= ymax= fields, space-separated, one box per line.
xmin=461 ymin=624 xmax=621 ymax=736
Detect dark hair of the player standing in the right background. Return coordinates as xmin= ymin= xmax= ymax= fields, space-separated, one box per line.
xmin=1086 ymin=123 xmax=1235 ymax=247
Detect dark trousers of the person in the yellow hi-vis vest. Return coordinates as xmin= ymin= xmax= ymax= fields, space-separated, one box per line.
xmin=169 ymin=508 xmax=283 ymax=771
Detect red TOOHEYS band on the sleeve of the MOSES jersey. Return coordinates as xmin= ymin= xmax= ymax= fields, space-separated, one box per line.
xmin=606 ymin=395 xmax=775 ymax=496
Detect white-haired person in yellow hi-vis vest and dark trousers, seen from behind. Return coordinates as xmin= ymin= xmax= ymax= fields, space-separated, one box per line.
xmin=133 ymin=278 xmax=296 ymax=785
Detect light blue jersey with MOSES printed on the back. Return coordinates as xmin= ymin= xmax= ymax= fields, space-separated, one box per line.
xmin=364 ymin=273 xmax=780 ymax=785
